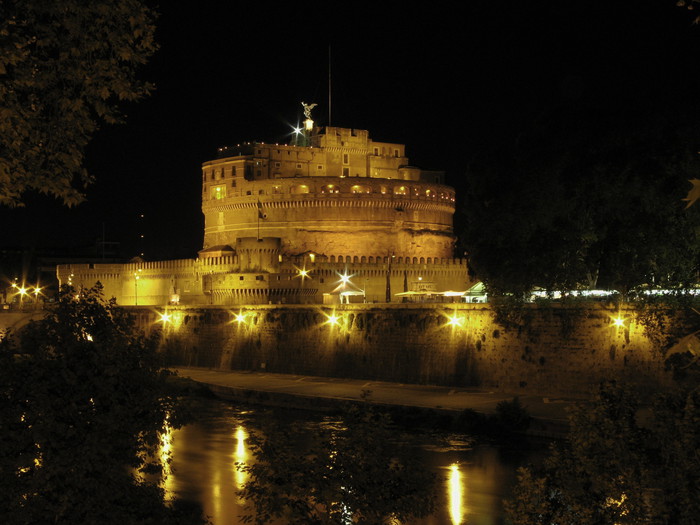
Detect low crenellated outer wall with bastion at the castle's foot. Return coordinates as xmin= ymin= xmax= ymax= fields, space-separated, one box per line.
xmin=57 ymin=255 xmax=473 ymax=306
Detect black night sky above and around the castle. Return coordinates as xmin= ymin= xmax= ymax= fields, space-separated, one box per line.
xmin=0 ymin=0 xmax=700 ymax=260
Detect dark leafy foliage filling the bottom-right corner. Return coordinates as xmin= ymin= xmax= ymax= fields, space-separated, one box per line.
xmin=506 ymin=383 xmax=700 ymax=525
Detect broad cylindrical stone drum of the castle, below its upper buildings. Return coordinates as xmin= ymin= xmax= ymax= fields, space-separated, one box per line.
xmin=202 ymin=176 xmax=455 ymax=257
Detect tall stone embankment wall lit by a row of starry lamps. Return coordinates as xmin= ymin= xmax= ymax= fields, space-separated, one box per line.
xmin=137 ymin=304 xmax=672 ymax=396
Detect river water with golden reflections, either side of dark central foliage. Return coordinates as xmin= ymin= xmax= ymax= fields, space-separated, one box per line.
xmin=162 ymin=400 xmax=541 ymax=525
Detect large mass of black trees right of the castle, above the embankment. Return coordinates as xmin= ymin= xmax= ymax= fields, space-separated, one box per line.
xmin=461 ymin=110 xmax=700 ymax=297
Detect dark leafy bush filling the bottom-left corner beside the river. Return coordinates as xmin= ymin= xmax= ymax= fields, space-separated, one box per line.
xmin=0 ymin=286 xmax=201 ymax=524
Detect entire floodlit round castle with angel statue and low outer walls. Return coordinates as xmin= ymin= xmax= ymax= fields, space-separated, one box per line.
xmin=57 ymin=104 xmax=470 ymax=305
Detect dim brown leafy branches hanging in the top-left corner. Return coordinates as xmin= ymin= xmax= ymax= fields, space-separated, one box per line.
xmin=0 ymin=0 xmax=156 ymax=206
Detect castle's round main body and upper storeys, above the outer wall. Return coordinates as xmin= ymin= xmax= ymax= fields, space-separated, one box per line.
xmin=202 ymin=127 xmax=455 ymax=258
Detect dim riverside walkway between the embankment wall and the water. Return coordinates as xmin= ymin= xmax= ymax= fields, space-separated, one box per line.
xmin=172 ymin=367 xmax=583 ymax=438
